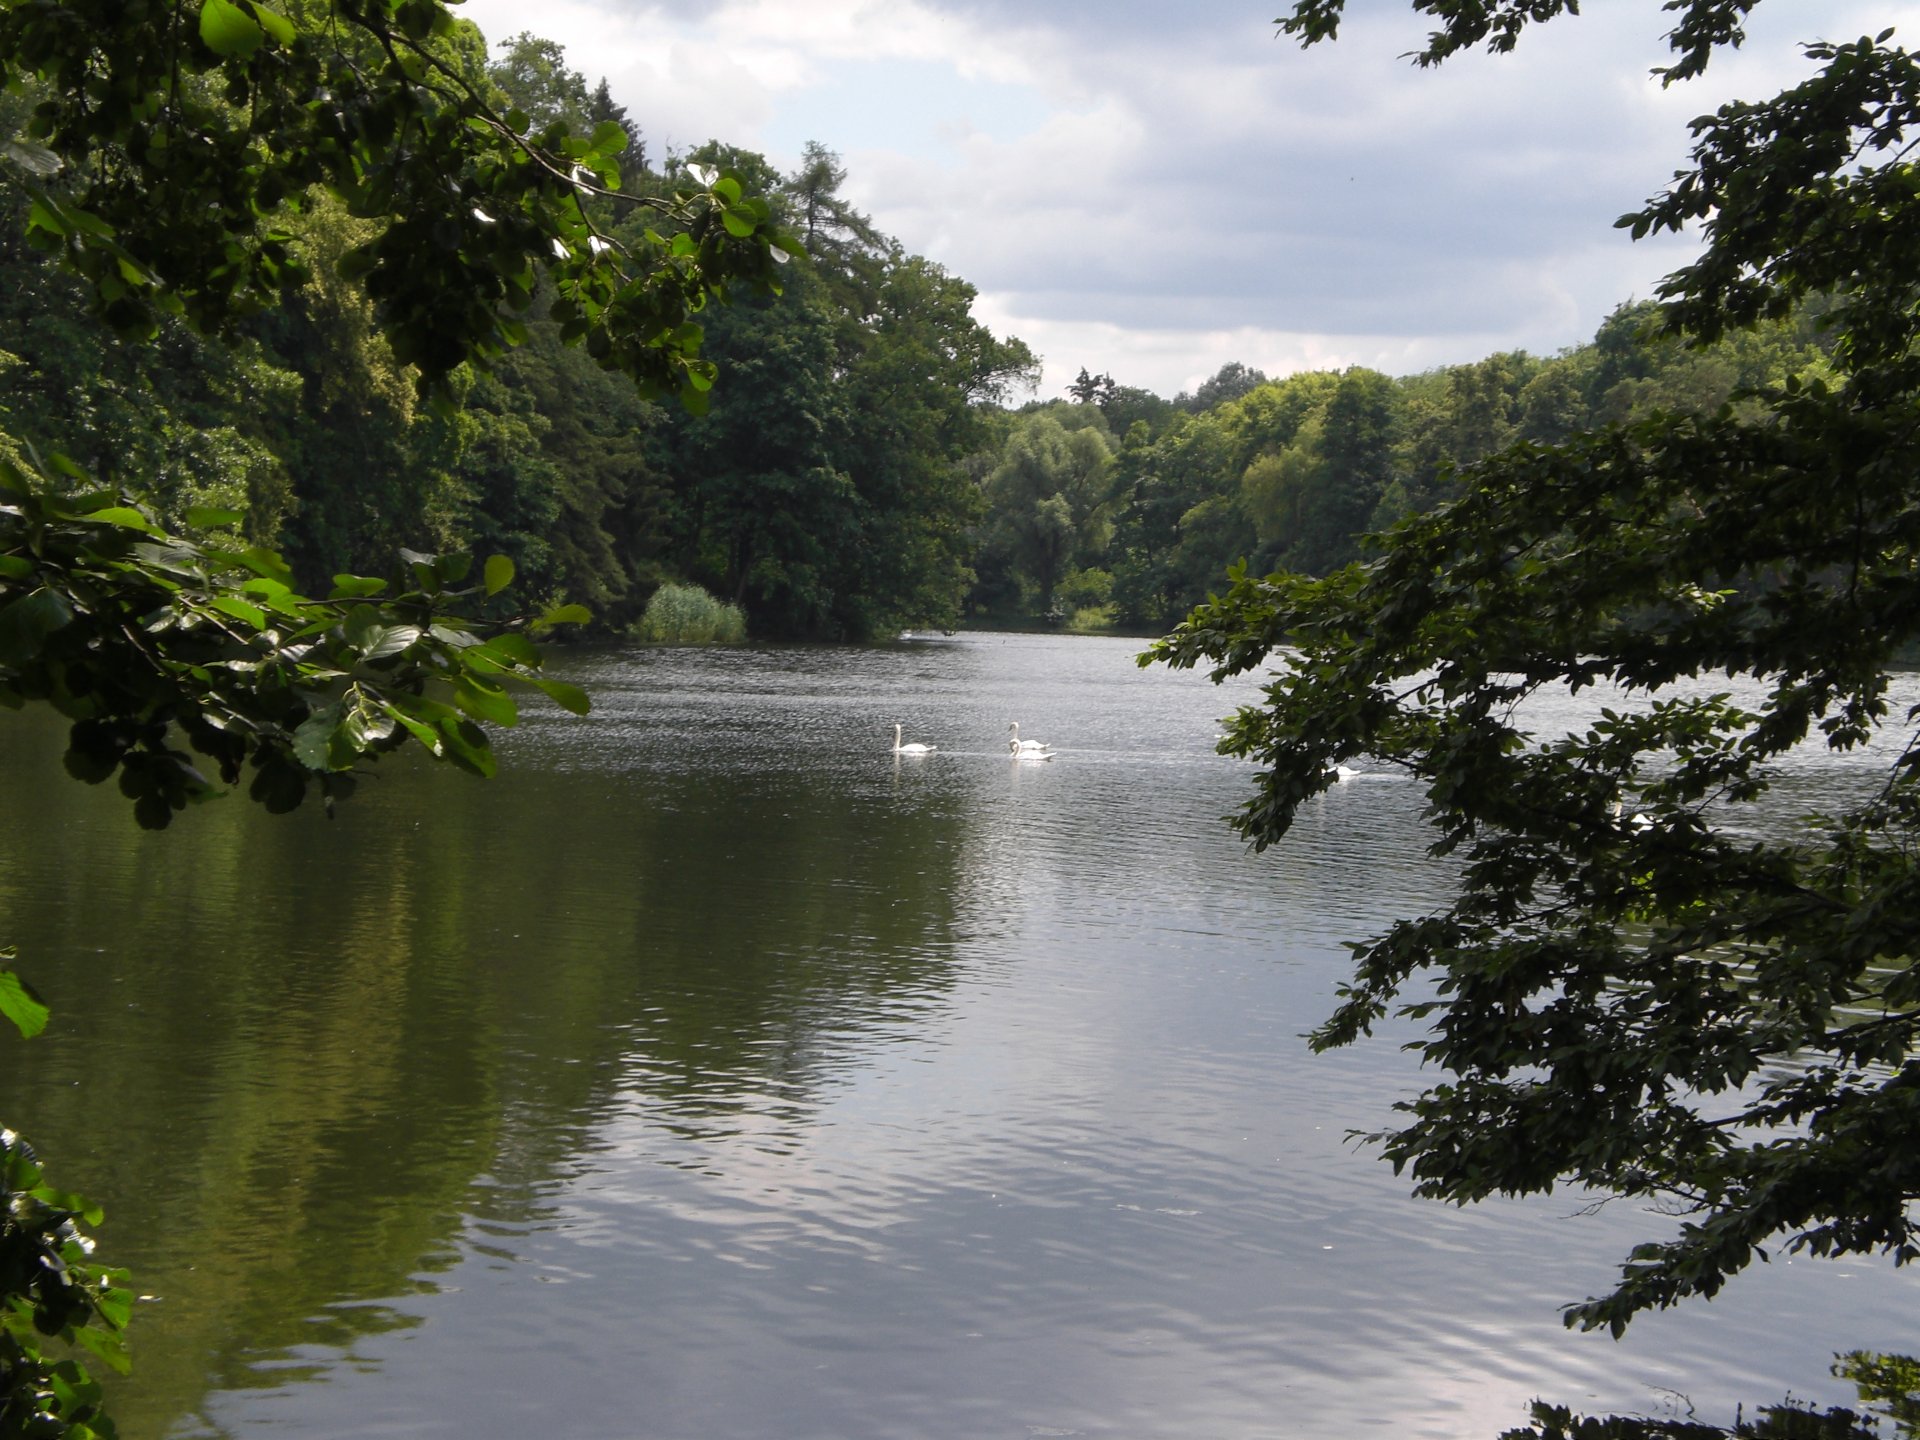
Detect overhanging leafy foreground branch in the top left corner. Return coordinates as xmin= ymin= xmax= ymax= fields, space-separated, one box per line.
xmin=0 ymin=0 xmax=791 ymax=403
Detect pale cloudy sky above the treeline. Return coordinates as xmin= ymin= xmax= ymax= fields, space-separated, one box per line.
xmin=461 ymin=0 xmax=1920 ymax=397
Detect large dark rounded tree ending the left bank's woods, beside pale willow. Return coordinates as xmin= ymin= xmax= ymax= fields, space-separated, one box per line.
xmin=659 ymin=146 xmax=1035 ymax=639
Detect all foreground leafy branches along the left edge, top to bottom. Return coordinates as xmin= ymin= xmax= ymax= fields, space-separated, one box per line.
xmin=0 ymin=0 xmax=799 ymax=1440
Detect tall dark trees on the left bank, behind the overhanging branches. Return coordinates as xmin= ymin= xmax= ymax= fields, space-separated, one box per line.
xmin=0 ymin=25 xmax=1033 ymax=637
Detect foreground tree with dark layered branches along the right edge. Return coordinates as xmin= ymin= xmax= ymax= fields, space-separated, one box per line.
xmin=1152 ymin=0 xmax=1920 ymax=1434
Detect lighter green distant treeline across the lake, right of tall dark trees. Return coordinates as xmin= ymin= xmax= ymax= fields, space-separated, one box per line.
xmin=970 ymin=298 xmax=1832 ymax=630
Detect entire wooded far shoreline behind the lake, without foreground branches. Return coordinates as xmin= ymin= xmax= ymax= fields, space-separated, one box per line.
xmin=0 ymin=25 xmax=1824 ymax=639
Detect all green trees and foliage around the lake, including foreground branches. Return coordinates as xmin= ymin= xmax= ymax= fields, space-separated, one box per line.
xmin=0 ymin=0 xmax=1920 ymax=1436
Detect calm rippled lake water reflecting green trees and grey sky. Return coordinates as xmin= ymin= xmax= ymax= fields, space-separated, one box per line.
xmin=0 ymin=636 xmax=1920 ymax=1440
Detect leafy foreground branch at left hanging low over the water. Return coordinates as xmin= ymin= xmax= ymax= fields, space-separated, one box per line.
xmin=0 ymin=451 xmax=586 ymax=829
